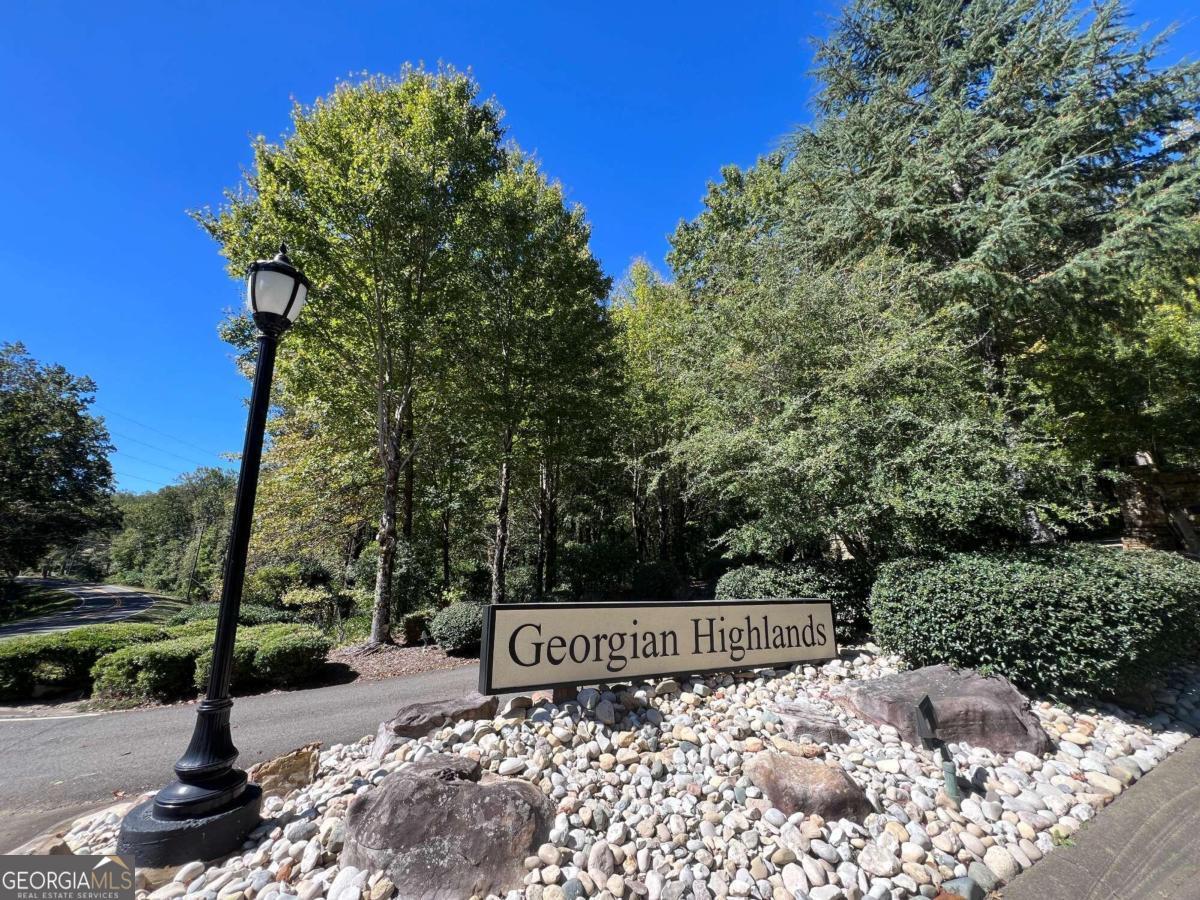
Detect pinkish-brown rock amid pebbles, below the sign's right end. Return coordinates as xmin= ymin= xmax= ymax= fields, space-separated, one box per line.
xmin=745 ymin=751 xmax=871 ymax=822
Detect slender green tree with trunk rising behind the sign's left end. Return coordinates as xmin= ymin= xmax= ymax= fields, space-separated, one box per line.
xmin=456 ymin=152 xmax=608 ymax=602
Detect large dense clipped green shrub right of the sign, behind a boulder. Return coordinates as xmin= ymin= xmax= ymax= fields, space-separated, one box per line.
xmin=871 ymin=545 xmax=1200 ymax=697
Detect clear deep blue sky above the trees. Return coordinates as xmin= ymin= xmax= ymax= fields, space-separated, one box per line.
xmin=0 ymin=0 xmax=1200 ymax=490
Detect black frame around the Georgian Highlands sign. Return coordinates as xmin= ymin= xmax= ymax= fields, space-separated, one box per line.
xmin=479 ymin=596 xmax=841 ymax=696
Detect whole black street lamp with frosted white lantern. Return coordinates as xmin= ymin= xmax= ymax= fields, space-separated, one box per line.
xmin=116 ymin=245 xmax=308 ymax=868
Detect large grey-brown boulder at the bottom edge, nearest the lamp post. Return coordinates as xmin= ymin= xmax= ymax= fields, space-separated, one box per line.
xmin=340 ymin=754 xmax=554 ymax=900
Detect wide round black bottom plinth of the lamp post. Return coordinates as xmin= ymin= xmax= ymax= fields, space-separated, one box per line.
xmin=116 ymin=785 xmax=263 ymax=869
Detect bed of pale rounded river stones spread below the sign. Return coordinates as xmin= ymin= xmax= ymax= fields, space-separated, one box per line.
xmin=49 ymin=647 xmax=1200 ymax=900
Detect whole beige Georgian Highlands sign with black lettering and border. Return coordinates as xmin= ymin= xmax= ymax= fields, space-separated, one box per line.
xmin=479 ymin=599 xmax=838 ymax=694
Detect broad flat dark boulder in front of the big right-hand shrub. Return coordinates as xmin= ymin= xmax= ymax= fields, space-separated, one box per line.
xmin=833 ymin=666 xmax=1052 ymax=756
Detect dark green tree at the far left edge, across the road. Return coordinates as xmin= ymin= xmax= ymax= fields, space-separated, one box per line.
xmin=0 ymin=343 xmax=118 ymax=578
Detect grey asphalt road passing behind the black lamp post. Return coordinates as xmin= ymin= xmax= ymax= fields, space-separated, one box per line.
xmin=0 ymin=666 xmax=479 ymax=852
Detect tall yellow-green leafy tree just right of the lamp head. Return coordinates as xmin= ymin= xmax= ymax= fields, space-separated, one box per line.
xmin=200 ymin=68 xmax=502 ymax=644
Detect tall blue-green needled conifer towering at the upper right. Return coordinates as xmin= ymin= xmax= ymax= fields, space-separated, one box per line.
xmin=671 ymin=0 xmax=1200 ymax=546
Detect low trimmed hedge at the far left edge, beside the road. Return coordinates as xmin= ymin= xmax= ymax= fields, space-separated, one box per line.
xmin=0 ymin=623 xmax=169 ymax=700
